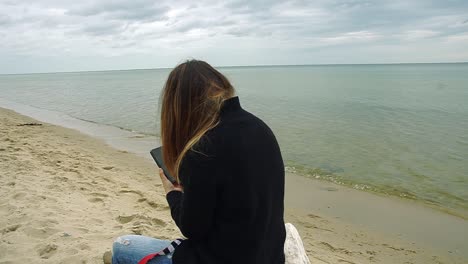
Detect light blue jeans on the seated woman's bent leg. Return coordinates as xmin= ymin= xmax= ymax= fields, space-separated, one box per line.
xmin=112 ymin=235 xmax=172 ymax=264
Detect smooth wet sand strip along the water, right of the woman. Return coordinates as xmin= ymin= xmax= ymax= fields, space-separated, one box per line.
xmin=285 ymin=174 xmax=468 ymax=259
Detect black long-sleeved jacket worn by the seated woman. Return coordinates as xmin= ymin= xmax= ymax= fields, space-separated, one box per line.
xmin=167 ymin=97 xmax=286 ymax=264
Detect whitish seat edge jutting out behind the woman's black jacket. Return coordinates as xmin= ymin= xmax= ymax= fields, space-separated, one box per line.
xmin=284 ymin=223 xmax=310 ymax=264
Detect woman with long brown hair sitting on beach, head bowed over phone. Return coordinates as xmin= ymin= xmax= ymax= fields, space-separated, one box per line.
xmin=113 ymin=60 xmax=286 ymax=264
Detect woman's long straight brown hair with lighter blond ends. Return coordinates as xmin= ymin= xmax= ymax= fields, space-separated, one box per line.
xmin=161 ymin=60 xmax=234 ymax=181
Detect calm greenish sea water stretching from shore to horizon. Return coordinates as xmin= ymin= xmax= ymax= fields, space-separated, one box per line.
xmin=0 ymin=63 xmax=468 ymax=218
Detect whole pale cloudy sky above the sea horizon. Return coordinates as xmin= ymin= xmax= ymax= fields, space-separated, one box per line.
xmin=0 ymin=0 xmax=468 ymax=73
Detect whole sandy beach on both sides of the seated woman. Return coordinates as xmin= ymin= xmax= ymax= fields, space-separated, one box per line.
xmin=0 ymin=108 xmax=468 ymax=264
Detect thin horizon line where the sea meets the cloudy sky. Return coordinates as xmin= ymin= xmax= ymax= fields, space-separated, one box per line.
xmin=0 ymin=61 xmax=468 ymax=76
